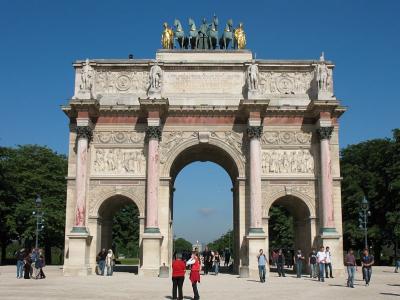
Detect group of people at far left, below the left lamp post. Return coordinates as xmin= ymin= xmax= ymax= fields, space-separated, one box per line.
xmin=15 ymin=248 xmax=46 ymax=279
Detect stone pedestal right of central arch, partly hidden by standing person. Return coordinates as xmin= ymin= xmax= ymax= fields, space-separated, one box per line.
xmin=243 ymin=233 xmax=269 ymax=279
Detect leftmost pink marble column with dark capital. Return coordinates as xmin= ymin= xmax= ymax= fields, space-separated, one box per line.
xmin=74 ymin=126 xmax=92 ymax=230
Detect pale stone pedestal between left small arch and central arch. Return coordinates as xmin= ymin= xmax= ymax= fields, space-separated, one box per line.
xmin=140 ymin=233 xmax=163 ymax=277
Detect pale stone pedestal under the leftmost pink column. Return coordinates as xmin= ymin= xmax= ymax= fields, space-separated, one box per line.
xmin=63 ymin=227 xmax=92 ymax=276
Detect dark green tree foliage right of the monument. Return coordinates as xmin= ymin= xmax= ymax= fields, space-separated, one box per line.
xmin=341 ymin=129 xmax=400 ymax=260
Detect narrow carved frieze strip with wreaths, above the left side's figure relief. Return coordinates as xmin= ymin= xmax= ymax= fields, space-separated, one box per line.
xmin=93 ymin=131 xmax=144 ymax=144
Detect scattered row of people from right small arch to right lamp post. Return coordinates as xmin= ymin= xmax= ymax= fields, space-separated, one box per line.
xmin=257 ymin=246 xmax=375 ymax=288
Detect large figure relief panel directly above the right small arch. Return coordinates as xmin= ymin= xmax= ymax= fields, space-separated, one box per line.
xmin=261 ymin=149 xmax=314 ymax=174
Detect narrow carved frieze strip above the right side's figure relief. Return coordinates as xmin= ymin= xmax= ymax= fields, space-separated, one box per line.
xmin=261 ymin=131 xmax=312 ymax=145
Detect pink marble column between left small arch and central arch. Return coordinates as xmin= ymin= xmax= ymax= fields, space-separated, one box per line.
xmin=145 ymin=126 xmax=161 ymax=233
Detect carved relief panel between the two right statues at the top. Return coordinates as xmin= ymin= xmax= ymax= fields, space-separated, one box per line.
xmin=260 ymin=72 xmax=314 ymax=94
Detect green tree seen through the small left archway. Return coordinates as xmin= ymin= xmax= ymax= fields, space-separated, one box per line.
xmin=112 ymin=203 xmax=140 ymax=258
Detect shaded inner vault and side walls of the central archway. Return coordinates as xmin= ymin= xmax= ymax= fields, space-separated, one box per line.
xmin=170 ymin=143 xmax=240 ymax=272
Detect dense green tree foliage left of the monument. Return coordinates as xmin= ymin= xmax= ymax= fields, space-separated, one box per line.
xmin=0 ymin=145 xmax=67 ymax=261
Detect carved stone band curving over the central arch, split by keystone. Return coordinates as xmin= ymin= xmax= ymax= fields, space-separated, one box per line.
xmin=161 ymin=137 xmax=246 ymax=179
